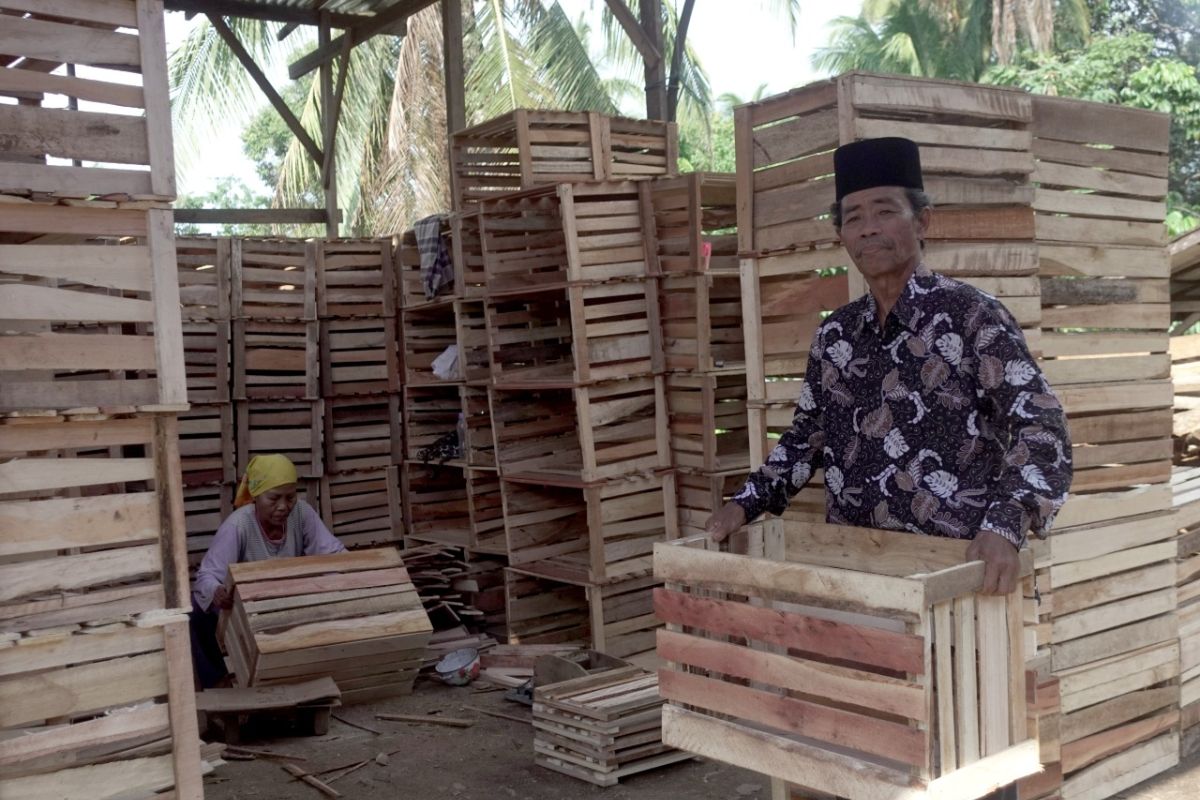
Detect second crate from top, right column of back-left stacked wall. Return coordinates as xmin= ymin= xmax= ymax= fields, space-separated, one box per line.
xmin=319 ymin=317 xmax=400 ymax=397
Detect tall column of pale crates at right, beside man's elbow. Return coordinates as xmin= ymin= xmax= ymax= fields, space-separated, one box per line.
xmin=1032 ymin=96 xmax=1180 ymax=800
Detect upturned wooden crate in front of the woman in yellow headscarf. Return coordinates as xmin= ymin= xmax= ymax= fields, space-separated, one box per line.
xmin=222 ymin=548 xmax=433 ymax=703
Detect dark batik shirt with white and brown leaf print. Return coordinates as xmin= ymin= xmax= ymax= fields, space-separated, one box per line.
xmin=733 ymin=267 xmax=1072 ymax=547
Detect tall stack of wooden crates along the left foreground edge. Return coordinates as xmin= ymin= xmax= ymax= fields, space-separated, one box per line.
xmin=0 ymin=0 xmax=203 ymax=800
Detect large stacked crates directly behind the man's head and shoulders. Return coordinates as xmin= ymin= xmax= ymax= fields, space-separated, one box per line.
xmin=734 ymin=73 xmax=1040 ymax=532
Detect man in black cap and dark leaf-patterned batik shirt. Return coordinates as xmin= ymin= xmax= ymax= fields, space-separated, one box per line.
xmin=707 ymin=138 xmax=1072 ymax=594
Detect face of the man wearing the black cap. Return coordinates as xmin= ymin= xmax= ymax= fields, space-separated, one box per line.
xmin=841 ymin=186 xmax=931 ymax=278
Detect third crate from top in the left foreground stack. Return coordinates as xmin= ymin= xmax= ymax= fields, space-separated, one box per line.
xmin=0 ymin=415 xmax=191 ymax=618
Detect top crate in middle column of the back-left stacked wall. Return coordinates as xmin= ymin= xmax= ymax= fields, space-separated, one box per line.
xmin=229 ymin=239 xmax=320 ymax=321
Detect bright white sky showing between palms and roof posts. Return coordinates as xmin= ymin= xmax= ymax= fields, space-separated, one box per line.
xmin=167 ymin=0 xmax=862 ymax=194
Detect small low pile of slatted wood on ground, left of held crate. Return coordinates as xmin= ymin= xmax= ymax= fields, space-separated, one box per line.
xmin=533 ymin=656 xmax=691 ymax=786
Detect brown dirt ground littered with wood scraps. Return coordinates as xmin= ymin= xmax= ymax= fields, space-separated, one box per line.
xmin=204 ymin=680 xmax=1200 ymax=800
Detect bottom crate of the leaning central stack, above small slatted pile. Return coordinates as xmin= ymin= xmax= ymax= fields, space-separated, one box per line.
xmin=505 ymin=567 xmax=662 ymax=668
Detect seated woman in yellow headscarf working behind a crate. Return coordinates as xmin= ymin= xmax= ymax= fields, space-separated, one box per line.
xmin=192 ymin=453 xmax=346 ymax=688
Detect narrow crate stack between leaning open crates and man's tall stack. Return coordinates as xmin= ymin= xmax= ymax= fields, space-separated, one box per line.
xmin=650 ymin=173 xmax=750 ymax=539
